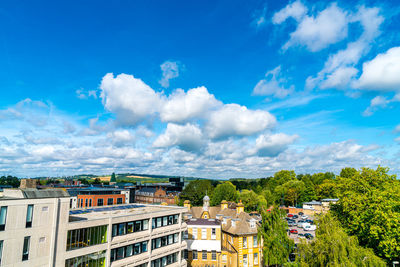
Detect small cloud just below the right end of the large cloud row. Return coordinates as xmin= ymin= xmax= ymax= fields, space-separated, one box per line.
xmin=255 ymin=133 xmax=299 ymax=157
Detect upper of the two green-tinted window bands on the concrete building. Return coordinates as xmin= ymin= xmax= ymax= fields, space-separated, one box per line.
xmin=67 ymin=225 xmax=107 ymax=251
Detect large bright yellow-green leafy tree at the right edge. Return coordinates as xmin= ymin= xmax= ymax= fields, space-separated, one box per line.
xmin=332 ymin=167 xmax=400 ymax=261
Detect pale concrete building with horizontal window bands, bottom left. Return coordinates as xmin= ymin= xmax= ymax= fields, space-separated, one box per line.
xmin=0 ymin=189 xmax=187 ymax=267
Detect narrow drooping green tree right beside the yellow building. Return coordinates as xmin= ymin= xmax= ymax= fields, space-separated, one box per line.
xmin=259 ymin=208 xmax=294 ymax=266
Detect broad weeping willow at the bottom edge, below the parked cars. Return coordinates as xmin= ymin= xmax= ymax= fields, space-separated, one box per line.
xmin=296 ymin=213 xmax=386 ymax=267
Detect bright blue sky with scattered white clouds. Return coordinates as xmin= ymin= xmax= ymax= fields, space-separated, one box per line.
xmin=0 ymin=1 xmax=400 ymax=178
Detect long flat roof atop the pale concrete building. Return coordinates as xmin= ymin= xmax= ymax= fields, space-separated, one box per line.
xmin=69 ymin=204 xmax=186 ymax=222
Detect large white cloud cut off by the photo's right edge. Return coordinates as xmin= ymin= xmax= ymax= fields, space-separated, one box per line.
xmin=356 ymin=47 xmax=400 ymax=91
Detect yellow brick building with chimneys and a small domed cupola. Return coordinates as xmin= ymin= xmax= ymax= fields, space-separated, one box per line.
xmin=185 ymin=196 xmax=262 ymax=267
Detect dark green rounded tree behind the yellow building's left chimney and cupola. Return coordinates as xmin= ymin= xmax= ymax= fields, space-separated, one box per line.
xmin=179 ymin=180 xmax=213 ymax=206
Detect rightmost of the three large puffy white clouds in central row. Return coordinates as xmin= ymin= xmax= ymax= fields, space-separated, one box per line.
xmin=206 ymin=104 xmax=276 ymax=139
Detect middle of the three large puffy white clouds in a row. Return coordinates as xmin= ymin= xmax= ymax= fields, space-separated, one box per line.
xmin=160 ymin=86 xmax=222 ymax=122
